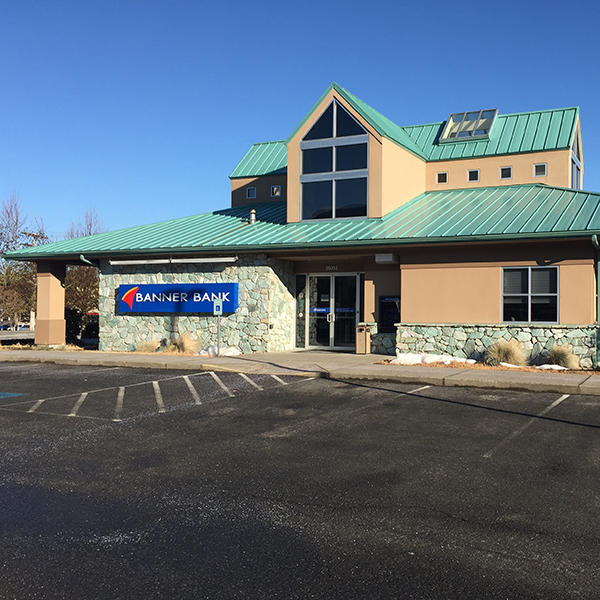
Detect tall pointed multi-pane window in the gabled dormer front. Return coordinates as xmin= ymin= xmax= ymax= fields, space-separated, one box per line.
xmin=300 ymin=102 xmax=369 ymax=219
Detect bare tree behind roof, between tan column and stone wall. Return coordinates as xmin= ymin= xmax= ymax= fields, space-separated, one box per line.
xmin=65 ymin=210 xmax=102 ymax=319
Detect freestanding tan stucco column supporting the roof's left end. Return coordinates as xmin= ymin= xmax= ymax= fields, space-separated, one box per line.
xmin=35 ymin=262 xmax=66 ymax=344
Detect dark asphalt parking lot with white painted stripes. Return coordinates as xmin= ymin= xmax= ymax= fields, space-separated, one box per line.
xmin=0 ymin=364 xmax=600 ymax=599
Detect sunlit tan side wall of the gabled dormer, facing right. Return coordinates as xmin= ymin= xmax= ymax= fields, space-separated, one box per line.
xmin=382 ymin=138 xmax=427 ymax=217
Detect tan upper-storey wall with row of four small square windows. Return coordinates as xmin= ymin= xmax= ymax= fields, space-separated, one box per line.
xmin=425 ymin=150 xmax=571 ymax=191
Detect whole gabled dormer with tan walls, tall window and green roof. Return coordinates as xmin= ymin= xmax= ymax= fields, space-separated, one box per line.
xmin=287 ymin=84 xmax=425 ymax=222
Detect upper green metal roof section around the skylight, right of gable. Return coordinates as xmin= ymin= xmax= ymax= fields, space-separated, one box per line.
xmin=403 ymin=107 xmax=579 ymax=161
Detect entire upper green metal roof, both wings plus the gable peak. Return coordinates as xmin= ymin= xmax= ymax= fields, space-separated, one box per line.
xmin=230 ymin=83 xmax=579 ymax=178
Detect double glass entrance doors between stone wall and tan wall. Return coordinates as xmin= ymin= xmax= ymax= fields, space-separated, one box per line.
xmin=306 ymin=275 xmax=359 ymax=350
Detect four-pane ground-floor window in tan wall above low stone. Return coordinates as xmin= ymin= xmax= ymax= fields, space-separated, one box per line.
xmin=502 ymin=267 xmax=558 ymax=323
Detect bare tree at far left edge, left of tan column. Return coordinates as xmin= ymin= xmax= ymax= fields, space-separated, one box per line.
xmin=0 ymin=195 xmax=48 ymax=327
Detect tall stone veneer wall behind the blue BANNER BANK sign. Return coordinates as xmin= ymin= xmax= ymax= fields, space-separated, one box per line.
xmin=99 ymin=255 xmax=296 ymax=353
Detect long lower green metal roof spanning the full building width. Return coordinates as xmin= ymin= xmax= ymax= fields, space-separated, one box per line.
xmin=6 ymin=184 xmax=600 ymax=260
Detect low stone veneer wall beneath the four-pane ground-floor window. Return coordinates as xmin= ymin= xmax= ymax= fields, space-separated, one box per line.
xmin=396 ymin=323 xmax=598 ymax=369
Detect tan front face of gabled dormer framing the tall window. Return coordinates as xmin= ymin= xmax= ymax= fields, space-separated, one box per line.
xmin=287 ymin=90 xmax=381 ymax=223
